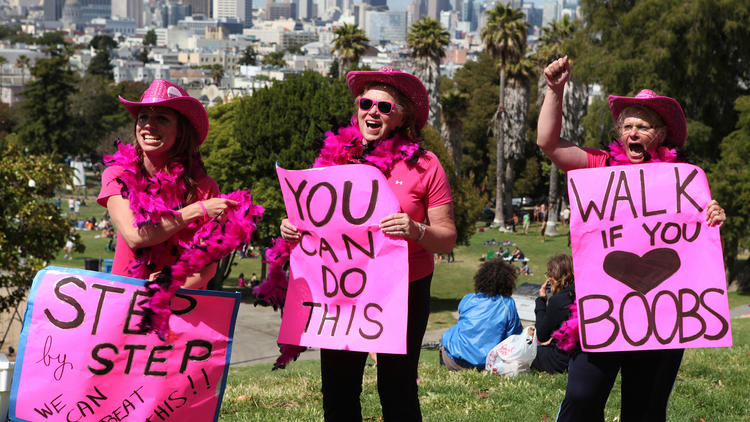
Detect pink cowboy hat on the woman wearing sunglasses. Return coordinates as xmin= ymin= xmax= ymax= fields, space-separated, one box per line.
xmin=346 ymin=66 xmax=430 ymax=130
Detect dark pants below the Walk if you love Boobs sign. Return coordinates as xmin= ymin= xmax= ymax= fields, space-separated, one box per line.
xmin=557 ymin=349 xmax=684 ymax=422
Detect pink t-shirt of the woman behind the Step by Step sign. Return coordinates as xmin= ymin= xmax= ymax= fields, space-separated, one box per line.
xmin=96 ymin=165 xmax=219 ymax=276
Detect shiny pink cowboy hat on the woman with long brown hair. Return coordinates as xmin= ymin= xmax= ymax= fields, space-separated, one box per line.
xmin=118 ymin=79 xmax=208 ymax=145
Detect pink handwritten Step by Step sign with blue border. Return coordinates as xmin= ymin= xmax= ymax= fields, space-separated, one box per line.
xmin=9 ymin=267 xmax=239 ymax=422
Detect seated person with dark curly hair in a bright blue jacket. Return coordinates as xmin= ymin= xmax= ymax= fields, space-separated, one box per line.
xmin=440 ymin=258 xmax=523 ymax=371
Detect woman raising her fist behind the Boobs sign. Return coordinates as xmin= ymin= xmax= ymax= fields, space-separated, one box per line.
xmin=537 ymin=57 xmax=726 ymax=422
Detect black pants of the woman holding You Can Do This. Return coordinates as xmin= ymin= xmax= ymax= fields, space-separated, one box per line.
xmin=320 ymin=274 xmax=432 ymax=422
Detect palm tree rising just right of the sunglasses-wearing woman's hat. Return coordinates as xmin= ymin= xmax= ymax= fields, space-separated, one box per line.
xmin=406 ymin=17 xmax=450 ymax=129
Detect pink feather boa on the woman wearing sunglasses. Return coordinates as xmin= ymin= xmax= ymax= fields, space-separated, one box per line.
xmin=253 ymin=116 xmax=423 ymax=370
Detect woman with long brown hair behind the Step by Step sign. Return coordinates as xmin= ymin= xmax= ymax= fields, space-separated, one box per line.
xmin=97 ymin=79 xmax=236 ymax=288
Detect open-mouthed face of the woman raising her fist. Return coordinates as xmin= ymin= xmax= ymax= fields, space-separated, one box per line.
xmin=617 ymin=106 xmax=667 ymax=164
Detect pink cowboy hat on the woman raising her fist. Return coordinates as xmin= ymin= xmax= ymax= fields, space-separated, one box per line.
xmin=609 ymin=89 xmax=687 ymax=148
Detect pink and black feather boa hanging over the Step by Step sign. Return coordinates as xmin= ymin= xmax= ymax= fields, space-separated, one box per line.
xmin=104 ymin=141 xmax=263 ymax=340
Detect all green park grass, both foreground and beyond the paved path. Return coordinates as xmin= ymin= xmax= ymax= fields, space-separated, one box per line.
xmin=52 ymin=198 xmax=750 ymax=422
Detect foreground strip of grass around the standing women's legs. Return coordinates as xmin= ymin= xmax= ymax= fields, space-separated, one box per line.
xmin=220 ymin=319 xmax=750 ymax=422
